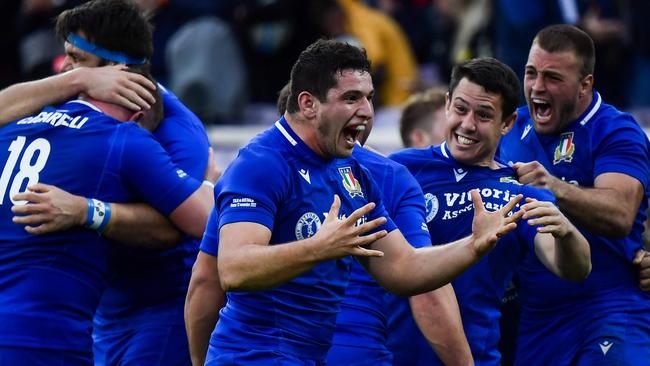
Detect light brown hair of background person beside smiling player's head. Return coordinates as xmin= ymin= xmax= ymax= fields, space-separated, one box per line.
xmin=399 ymin=87 xmax=447 ymax=146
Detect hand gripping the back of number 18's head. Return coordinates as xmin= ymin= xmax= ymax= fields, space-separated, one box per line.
xmin=78 ymin=65 xmax=156 ymax=111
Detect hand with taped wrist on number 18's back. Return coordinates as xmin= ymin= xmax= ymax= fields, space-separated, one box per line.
xmin=11 ymin=183 xmax=87 ymax=235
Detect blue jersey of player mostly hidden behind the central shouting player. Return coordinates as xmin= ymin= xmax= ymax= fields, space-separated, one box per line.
xmin=333 ymin=146 xmax=431 ymax=350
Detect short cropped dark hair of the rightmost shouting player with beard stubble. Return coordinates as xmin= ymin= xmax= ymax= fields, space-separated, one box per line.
xmin=533 ymin=24 xmax=596 ymax=78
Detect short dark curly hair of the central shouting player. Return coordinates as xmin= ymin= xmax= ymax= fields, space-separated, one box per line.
xmin=287 ymin=39 xmax=370 ymax=113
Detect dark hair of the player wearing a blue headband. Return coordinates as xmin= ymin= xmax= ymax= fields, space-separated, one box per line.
xmin=56 ymin=0 xmax=153 ymax=60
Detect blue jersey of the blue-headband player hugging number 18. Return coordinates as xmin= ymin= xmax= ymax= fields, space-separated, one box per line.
xmin=95 ymin=86 xmax=210 ymax=327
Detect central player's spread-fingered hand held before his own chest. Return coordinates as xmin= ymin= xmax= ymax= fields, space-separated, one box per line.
xmin=313 ymin=195 xmax=387 ymax=260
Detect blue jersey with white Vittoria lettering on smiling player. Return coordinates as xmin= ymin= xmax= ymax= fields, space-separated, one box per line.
xmin=390 ymin=143 xmax=554 ymax=365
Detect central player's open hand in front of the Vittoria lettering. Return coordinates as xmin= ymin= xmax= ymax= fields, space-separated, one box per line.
xmin=471 ymin=189 xmax=524 ymax=256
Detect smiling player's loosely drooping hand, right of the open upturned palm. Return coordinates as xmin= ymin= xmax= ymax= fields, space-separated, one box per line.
xmin=521 ymin=198 xmax=573 ymax=238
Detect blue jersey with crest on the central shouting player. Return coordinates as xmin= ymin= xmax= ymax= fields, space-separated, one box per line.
xmin=208 ymin=118 xmax=395 ymax=360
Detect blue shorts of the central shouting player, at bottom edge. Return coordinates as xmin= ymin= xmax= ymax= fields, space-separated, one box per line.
xmin=205 ymin=345 xmax=325 ymax=366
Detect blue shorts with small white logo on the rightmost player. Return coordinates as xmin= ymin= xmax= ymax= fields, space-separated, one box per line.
xmin=515 ymin=304 xmax=650 ymax=366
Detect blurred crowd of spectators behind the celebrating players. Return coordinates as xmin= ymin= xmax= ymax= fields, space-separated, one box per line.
xmin=0 ymin=0 xmax=650 ymax=126
